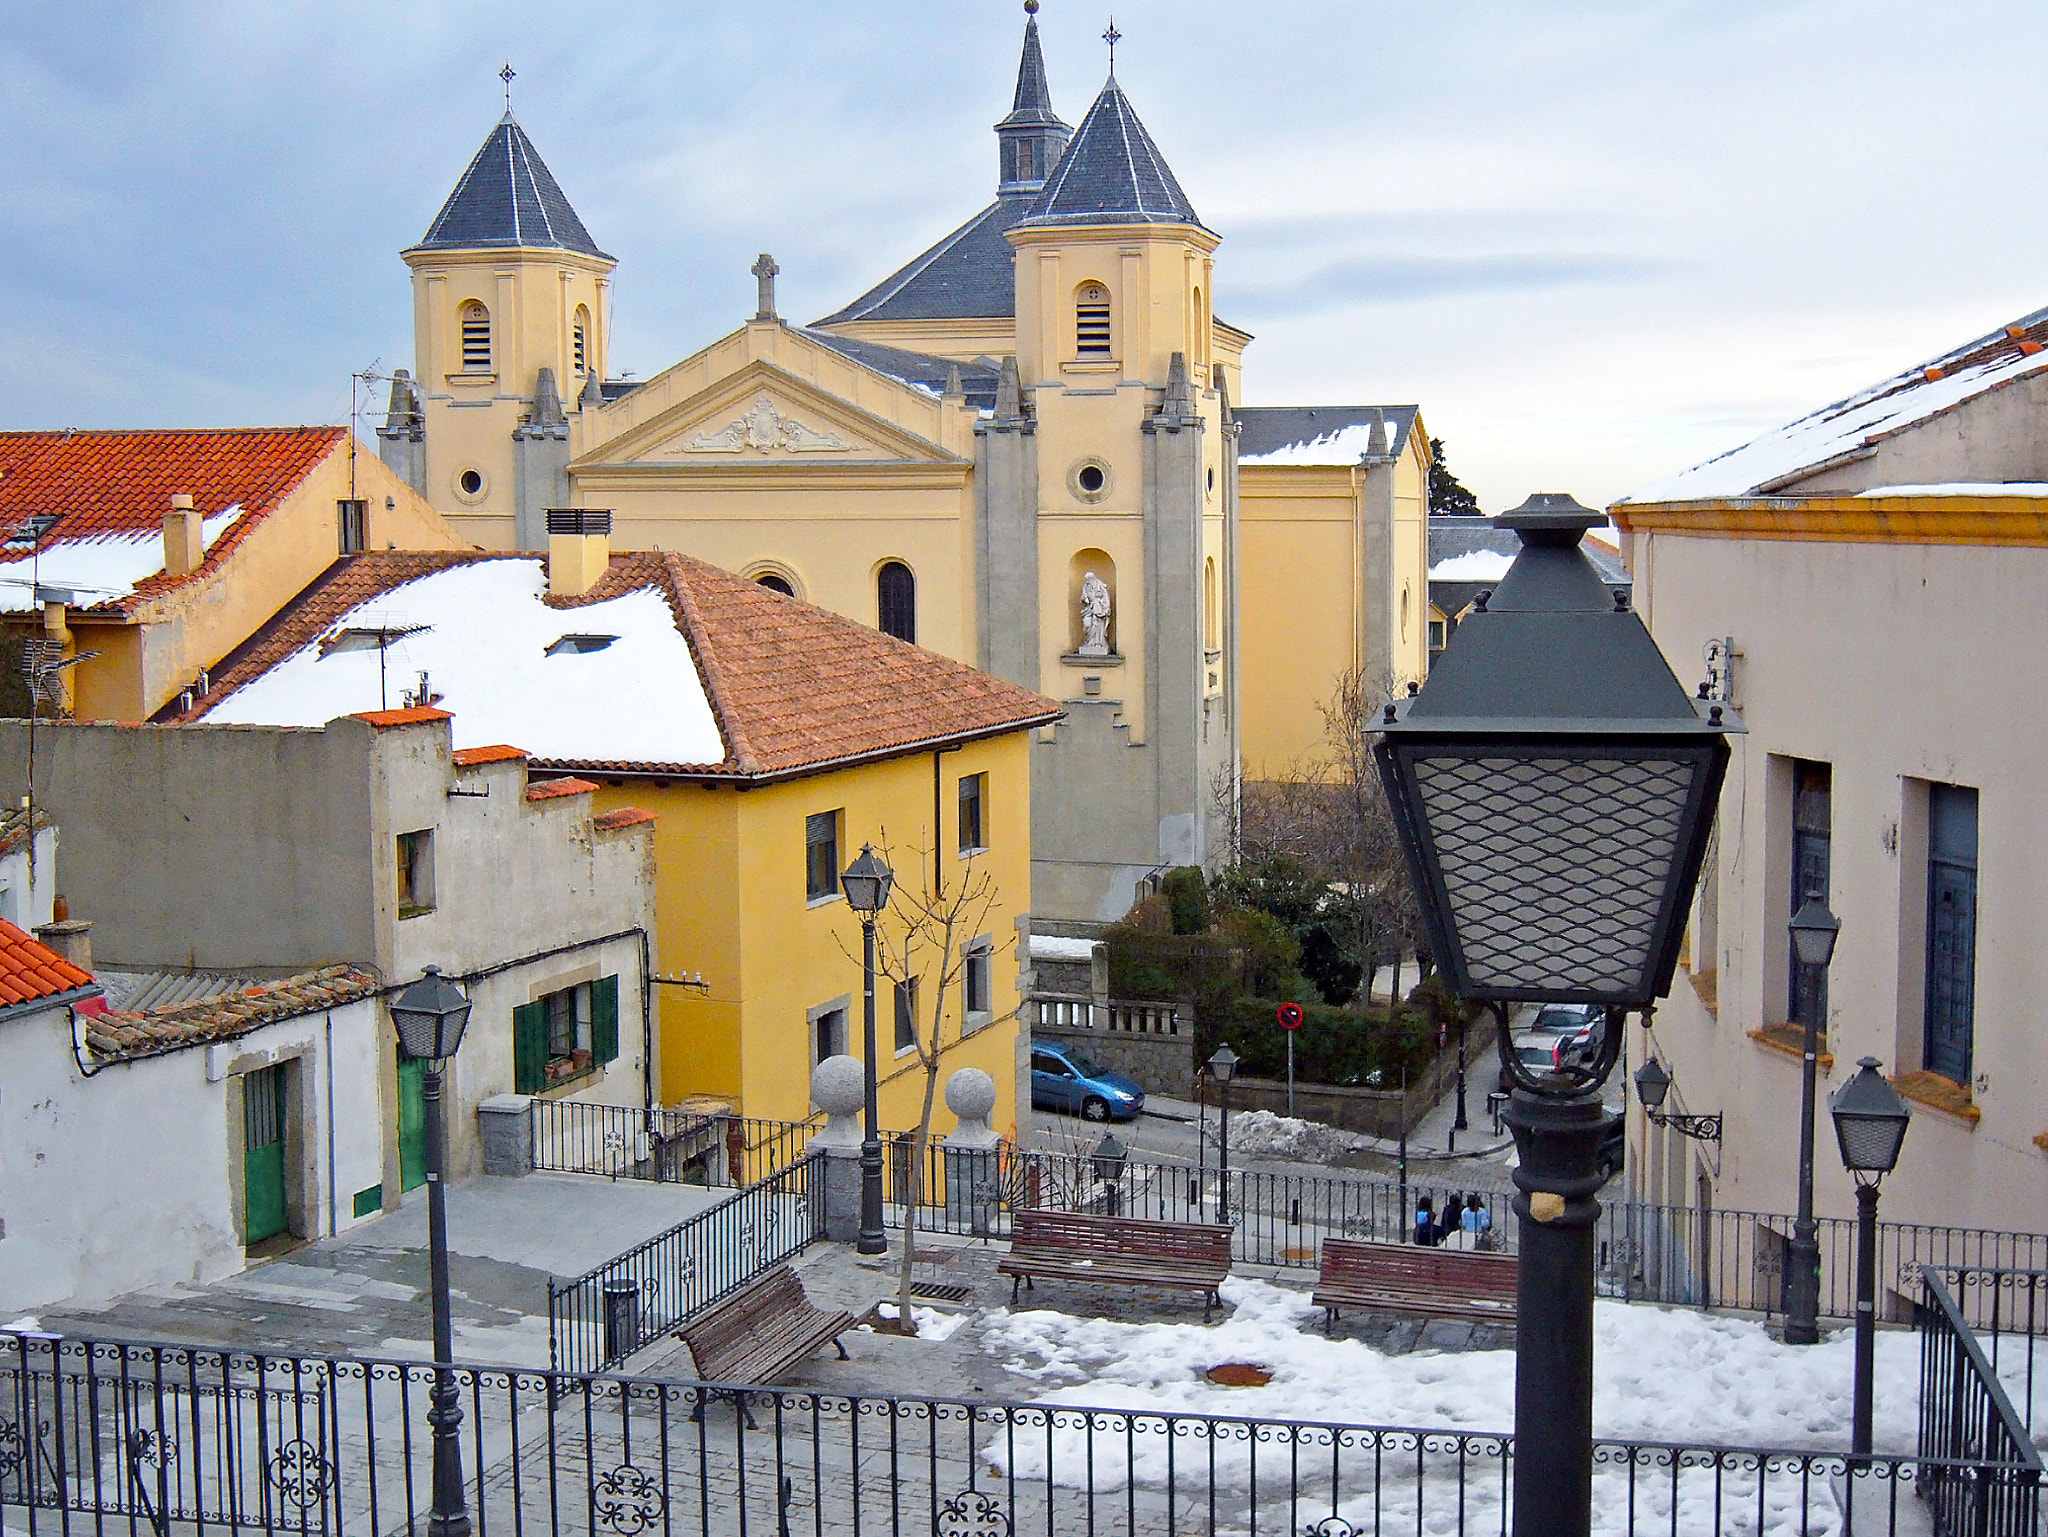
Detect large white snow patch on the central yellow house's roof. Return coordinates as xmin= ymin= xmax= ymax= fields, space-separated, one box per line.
xmin=207 ymin=557 xmax=725 ymax=762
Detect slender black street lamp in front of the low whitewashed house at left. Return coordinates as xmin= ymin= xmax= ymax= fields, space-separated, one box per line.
xmin=391 ymin=965 xmax=469 ymax=1537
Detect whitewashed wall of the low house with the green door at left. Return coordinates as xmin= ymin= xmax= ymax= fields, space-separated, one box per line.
xmin=0 ymin=998 xmax=389 ymax=1318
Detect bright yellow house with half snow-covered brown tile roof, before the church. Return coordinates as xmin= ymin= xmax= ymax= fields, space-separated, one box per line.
xmin=188 ymin=514 xmax=1059 ymax=1129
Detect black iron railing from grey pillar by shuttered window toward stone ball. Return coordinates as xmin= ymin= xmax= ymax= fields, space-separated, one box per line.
xmin=530 ymin=1098 xmax=823 ymax=1187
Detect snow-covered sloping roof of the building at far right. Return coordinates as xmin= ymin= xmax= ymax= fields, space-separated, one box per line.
xmin=1622 ymin=311 xmax=2048 ymax=502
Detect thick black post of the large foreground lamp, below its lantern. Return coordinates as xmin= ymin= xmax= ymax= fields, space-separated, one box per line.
xmin=1505 ymin=1088 xmax=1610 ymax=1537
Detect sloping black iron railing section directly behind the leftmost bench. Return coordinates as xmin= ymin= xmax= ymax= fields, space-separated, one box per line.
xmin=547 ymin=1158 xmax=825 ymax=1371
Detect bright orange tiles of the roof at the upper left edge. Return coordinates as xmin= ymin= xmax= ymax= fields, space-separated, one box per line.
xmin=0 ymin=426 xmax=348 ymax=611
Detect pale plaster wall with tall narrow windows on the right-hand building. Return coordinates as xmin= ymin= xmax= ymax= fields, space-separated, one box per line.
xmin=1626 ymin=528 xmax=2048 ymax=1232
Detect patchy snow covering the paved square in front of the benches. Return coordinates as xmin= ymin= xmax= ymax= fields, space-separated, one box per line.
xmin=983 ymin=1277 xmax=1919 ymax=1537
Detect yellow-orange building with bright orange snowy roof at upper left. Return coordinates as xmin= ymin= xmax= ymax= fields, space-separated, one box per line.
xmin=0 ymin=426 xmax=471 ymax=721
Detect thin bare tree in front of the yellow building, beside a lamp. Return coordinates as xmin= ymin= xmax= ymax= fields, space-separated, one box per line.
xmin=839 ymin=830 xmax=1016 ymax=1334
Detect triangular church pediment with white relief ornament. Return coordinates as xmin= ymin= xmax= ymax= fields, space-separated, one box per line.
xmin=580 ymin=363 xmax=952 ymax=467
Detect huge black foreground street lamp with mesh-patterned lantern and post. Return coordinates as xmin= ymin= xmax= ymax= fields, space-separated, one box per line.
xmin=1374 ymin=496 xmax=1741 ymax=1537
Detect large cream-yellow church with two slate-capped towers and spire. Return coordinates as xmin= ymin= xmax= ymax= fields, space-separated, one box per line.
xmin=379 ymin=0 xmax=1430 ymax=924
